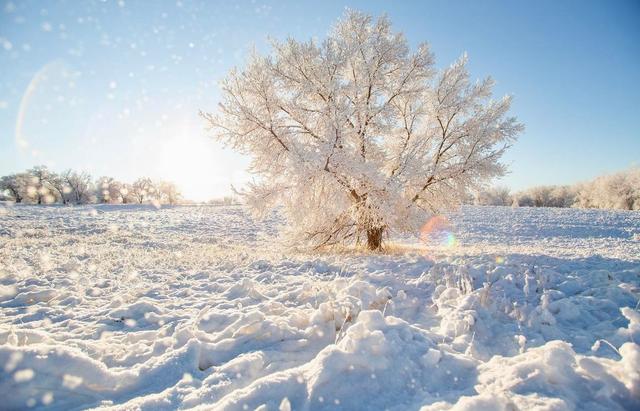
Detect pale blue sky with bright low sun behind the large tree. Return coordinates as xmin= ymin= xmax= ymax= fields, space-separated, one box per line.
xmin=0 ymin=0 xmax=640 ymax=200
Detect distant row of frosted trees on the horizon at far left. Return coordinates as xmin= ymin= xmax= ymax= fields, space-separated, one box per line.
xmin=0 ymin=166 xmax=182 ymax=204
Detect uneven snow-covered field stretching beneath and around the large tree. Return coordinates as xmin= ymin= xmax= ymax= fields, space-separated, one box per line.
xmin=0 ymin=206 xmax=640 ymax=411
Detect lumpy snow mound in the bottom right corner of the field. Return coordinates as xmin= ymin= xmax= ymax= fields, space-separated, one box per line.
xmin=422 ymin=341 xmax=640 ymax=410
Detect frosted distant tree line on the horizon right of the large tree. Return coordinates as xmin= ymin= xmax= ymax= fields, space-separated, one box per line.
xmin=467 ymin=167 xmax=640 ymax=210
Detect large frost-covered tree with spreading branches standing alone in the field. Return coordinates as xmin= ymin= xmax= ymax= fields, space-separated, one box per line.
xmin=202 ymin=11 xmax=522 ymax=250
